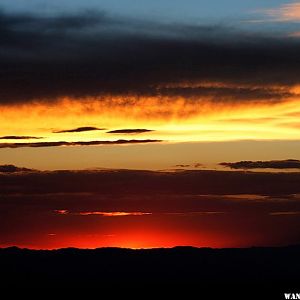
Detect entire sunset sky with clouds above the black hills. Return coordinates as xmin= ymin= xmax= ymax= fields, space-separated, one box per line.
xmin=0 ymin=0 xmax=300 ymax=248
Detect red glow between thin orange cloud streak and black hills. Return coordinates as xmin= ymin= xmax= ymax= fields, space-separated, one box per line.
xmin=0 ymin=214 xmax=298 ymax=249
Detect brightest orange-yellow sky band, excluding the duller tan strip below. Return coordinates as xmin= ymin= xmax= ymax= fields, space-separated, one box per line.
xmin=0 ymin=84 xmax=300 ymax=143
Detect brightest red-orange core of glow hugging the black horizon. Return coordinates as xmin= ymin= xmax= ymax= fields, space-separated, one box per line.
xmin=1 ymin=231 xmax=241 ymax=250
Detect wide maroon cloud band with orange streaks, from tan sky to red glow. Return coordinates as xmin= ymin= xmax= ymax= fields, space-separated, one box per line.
xmin=0 ymin=168 xmax=300 ymax=219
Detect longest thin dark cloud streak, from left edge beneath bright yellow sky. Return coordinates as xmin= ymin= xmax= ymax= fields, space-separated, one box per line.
xmin=0 ymin=139 xmax=162 ymax=149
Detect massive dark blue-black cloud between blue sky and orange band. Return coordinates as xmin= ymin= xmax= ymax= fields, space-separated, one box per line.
xmin=0 ymin=13 xmax=300 ymax=103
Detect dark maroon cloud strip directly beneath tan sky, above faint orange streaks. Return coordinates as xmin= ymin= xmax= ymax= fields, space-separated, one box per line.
xmin=0 ymin=170 xmax=300 ymax=196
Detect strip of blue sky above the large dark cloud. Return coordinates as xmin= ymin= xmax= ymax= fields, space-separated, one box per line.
xmin=1 ymin=0 xmax=290 ymax=21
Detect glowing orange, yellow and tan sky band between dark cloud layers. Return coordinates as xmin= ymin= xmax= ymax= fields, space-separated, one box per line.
xmin=0 ymin=82 xmax=300 ymax=170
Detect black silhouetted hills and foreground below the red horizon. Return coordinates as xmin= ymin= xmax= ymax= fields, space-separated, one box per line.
xmin=0 ymin=246 xmax=300 ymax=292
